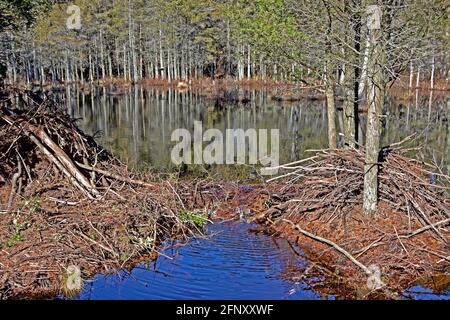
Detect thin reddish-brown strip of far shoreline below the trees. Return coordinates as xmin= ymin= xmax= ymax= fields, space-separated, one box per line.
xmin=7 ymin=77 xmax=450 ymax=104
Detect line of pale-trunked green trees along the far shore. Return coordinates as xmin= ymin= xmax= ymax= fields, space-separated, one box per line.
xmin=0 ymin=0 xmax=448 ymax=87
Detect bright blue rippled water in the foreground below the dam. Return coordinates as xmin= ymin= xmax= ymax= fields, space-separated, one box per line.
xmin=80 ymin=222 xmax=326 ymax=300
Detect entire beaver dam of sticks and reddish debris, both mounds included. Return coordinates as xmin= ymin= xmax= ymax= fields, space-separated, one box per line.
xmin=0 ymin=90 xmax=450 ymax=299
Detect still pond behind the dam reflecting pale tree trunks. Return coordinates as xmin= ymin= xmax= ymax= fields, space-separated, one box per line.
xmin=57 ymin=86 xmax=450 ymax=172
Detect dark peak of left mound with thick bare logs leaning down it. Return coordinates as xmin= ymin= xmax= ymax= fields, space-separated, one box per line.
xmin=0 ymin=99 xmax=117 ymax=200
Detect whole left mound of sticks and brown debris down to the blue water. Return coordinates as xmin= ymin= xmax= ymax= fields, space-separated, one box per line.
xmin=0 ymin=94 xmax=214 ymax=299
